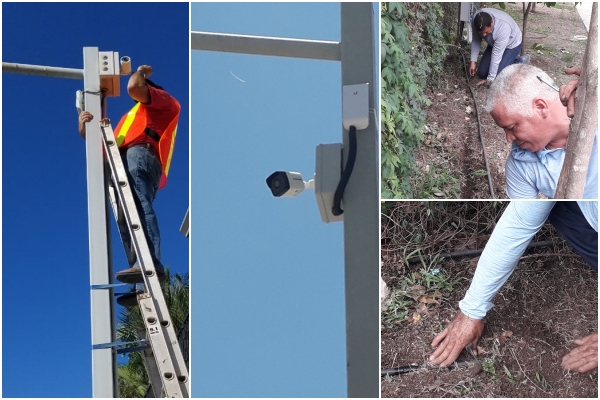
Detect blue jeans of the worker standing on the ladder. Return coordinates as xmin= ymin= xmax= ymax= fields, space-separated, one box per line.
xmin=119 ymin=145 xmax=162 ymax=268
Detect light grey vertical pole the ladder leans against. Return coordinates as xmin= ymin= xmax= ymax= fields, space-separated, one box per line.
xmin=83 ymin=47 xmax=118 ymax=398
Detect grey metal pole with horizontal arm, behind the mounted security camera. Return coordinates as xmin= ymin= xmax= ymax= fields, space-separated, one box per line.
xmin=191 ymin=3 xmax=380 ymax=398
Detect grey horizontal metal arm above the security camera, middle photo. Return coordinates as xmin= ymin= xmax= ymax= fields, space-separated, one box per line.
xmin=191 ymin=32 xmax=341 ymax=61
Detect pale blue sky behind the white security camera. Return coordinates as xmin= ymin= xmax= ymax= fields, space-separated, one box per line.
xmin=191 ymin=3 xmax=379 ymax=397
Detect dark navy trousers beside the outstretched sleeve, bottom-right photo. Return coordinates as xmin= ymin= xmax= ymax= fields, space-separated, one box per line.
xmin=548 ymin=201 xmax=598 ymax=272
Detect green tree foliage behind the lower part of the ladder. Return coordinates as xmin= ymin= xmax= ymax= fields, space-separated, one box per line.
xmin=117 ymin=268 xmax=189 ymax=398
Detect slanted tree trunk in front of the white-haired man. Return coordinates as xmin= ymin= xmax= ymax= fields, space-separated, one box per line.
xmin=554 ymin=2 xmax=598 ymax=199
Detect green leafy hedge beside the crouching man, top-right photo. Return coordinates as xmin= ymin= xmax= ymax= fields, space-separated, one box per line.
xmin=381 ymin=3 xmax=447 ymax=199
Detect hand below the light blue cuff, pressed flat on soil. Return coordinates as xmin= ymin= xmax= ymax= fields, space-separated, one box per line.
xmin=429 ymin=311 xmax=484 ymax=368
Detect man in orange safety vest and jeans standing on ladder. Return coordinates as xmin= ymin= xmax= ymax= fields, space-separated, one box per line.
xmin=79 ymin=65 xmax=181 ymax=305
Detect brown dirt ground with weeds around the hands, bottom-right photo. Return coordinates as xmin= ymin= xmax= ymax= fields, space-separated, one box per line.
xmin=381 ymin=202 xmax=598 ymax=398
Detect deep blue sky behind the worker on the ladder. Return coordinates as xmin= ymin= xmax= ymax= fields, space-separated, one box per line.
xmin=2 ymin=3 xmax=190 ymax=397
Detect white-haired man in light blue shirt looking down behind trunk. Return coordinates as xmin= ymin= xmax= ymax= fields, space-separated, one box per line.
xmin=486 ymin=64 xmax=598 ymax=199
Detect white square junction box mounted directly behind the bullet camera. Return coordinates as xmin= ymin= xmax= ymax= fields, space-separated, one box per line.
xmin=315 ymin=143 xmax=344 ymax=223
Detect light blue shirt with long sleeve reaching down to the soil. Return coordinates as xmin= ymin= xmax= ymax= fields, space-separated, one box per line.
xmin=458 ymin=201 xmax=598 ymax=319
